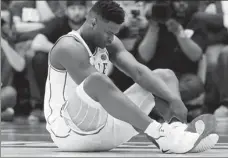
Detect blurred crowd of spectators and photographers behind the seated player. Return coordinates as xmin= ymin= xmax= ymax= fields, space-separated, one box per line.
xmin=1 ymin=0 xmax=228 ymax=122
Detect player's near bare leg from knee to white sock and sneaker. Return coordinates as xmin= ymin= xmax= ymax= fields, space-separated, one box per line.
xmin=83 ymin=73 xmax=199 ymax=153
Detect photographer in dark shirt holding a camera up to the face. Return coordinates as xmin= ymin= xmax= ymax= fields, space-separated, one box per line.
xmin=136 ymin=1 xmax=207 ymax=119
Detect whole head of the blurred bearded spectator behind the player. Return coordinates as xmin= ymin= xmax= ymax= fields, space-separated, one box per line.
xmin=66 ymin=0 xmax=87 ymax=24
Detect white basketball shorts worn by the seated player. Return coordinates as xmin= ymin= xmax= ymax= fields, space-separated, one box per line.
xmin=54 ymin=75 xmax=155 ymax=151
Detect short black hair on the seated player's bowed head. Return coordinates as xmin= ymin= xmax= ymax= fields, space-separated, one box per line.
xmin=90 ymin=0 xmax=125 ymax=24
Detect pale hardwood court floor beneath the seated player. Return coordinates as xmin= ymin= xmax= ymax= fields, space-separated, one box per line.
xmin=1 ymin=118 xmax=228 ymax=157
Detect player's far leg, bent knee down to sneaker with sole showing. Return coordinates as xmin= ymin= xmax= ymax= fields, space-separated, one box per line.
xmin=152 ymin=69 xmax=218 ymax=152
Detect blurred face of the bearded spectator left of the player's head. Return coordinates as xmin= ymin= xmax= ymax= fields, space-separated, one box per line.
xmin=67 ymin=5 xmax=87 ymax=24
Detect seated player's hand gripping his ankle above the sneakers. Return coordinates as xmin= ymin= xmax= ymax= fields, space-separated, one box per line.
xmin=169 ymin=99 xmax=188 ymax=123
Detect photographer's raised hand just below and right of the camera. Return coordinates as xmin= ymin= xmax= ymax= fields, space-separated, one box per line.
xmin=166 ymin=19 xmax=183 ymax=36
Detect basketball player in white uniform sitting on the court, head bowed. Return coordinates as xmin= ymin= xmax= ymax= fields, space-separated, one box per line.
xmin=44 ymin=0 xmax=218 ymax=153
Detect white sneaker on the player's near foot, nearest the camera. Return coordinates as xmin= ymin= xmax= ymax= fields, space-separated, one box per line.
xmin=154 ymin=123 xmax=200 ymax=154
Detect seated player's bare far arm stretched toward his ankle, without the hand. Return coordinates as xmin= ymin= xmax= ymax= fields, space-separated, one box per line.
xmin=106 ymin=37 xmax=178 ymax=103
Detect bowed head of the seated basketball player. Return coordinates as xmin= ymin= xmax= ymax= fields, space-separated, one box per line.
xmin=86 ymin=0 xmax=125 ymax=48
